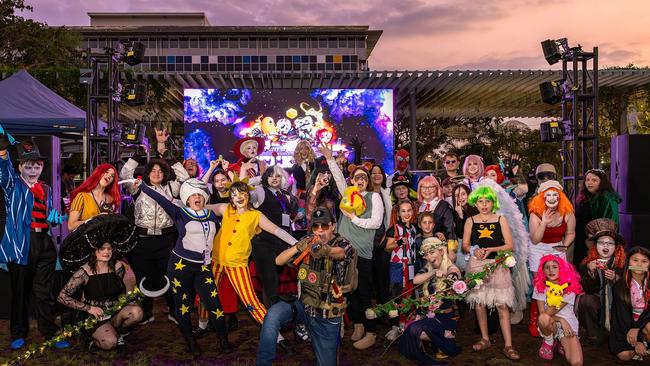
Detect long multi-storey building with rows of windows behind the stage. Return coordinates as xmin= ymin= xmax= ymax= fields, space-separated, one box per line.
xmin=70 ymin=13 xmax=382 ymax=72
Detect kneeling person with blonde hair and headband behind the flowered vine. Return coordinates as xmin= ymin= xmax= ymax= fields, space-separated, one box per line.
xmin=399 ymin=237 xmax=461 ymax=365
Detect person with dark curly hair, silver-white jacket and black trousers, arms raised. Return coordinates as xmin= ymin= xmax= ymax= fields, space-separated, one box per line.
xmin=120 ymin=159 xmax=189 ymax=323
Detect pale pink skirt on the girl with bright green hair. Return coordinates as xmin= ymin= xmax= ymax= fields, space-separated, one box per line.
xmin=466 ymin=256 xmax=515 ymax=308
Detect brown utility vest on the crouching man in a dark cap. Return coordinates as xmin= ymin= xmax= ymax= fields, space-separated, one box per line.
xmin=298 ymin=264 xmax=349 ymax=318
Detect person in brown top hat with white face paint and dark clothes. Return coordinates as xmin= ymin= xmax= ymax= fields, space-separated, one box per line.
xmin=577 ymin=219 xmax=625 ymax=345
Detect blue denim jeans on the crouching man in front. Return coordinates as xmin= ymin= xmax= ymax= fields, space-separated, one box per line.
xmin=256 ymin=300 xmax=341 ymax=366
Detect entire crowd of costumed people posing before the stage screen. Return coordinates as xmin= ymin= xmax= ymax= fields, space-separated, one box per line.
xmin=0 ymin=123 xmax=650 ymax=365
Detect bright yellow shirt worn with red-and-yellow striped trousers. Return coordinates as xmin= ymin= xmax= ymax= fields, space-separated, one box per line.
xmin=212 ymin=205 xmax=262 ymax=267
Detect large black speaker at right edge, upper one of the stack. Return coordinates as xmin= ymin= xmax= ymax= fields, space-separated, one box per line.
xmin=610 ymin=135 xmax=650 ymax=214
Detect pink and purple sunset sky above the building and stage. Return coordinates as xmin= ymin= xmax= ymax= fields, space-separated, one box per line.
xmin=25 ymin=0 xmax=650 ymax=70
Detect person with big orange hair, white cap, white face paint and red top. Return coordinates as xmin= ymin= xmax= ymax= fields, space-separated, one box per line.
xmin=528 ymin=180 xmax=576 ymax=337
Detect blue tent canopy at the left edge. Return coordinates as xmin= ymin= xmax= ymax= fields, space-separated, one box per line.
xmin=0 ymin=70 xmax=86 ymax=135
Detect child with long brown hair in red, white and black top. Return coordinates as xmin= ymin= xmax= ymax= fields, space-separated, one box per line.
xmin=386 ymin=200 xmax=417 ymax=341
